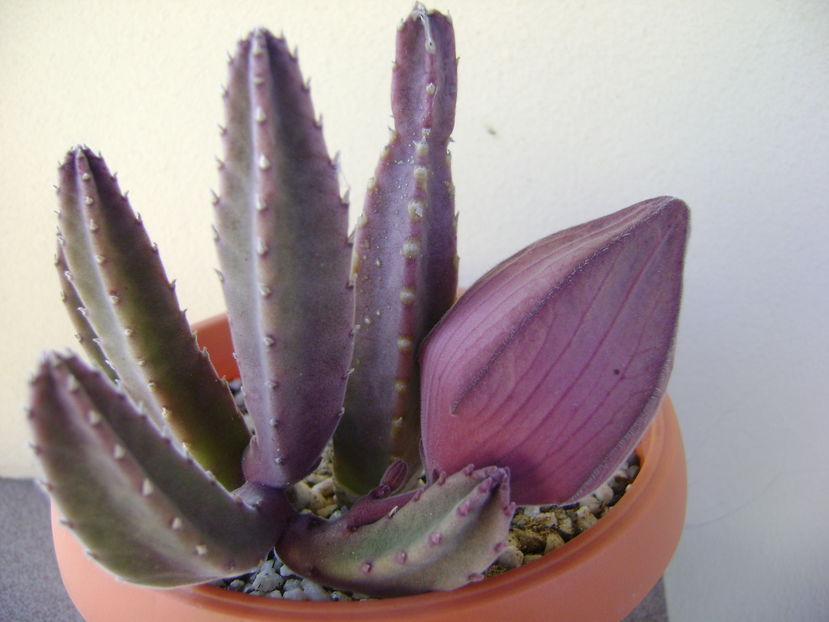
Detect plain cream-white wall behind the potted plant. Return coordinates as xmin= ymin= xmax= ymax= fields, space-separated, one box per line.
xmin=0 ymin=0 xmax=829 ymax=622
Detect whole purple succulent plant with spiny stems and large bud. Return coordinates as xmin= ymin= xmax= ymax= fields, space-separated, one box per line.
xmin=28 ymin=5 xmax=688 ymax=596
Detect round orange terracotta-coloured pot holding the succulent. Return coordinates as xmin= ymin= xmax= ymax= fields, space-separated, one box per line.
xmin=52 ymin=317 xmax=686 ymax=622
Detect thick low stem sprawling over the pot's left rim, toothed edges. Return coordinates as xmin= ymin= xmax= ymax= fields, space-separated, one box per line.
xmin=29 ymin=355 xmax=291 ymax=587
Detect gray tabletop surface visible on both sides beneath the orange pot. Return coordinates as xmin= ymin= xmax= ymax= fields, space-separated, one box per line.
xmin=0 ymin=478 xmax=668 ymax=622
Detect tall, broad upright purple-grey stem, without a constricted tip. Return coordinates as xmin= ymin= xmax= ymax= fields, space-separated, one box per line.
xmin=215 ymin=30 xmax=354 ymax=486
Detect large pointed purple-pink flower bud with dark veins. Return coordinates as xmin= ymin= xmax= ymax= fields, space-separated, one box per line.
xmin=422 ymin=197 xmax=688 ymax=504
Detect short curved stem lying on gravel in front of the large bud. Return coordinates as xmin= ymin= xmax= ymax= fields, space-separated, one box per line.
xmin=277 ymin=465 xmax=515 ymax=596
